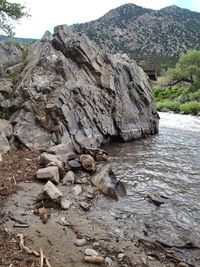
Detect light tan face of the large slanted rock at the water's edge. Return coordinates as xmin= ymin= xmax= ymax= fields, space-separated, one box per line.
xmin=91 ymin=164 xmax=118 ymax=200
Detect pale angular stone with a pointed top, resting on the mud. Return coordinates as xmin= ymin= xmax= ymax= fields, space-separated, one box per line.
xmin=37 ymin=181 xmax=62 ymax=201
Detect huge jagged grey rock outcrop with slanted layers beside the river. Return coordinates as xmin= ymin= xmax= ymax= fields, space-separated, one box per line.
xmin=1 ymin=26 xmax=158 ymax=152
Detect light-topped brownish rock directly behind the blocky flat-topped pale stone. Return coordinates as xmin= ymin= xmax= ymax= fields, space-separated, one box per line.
xmin=40 ymin=152 xmax=66 ymax=176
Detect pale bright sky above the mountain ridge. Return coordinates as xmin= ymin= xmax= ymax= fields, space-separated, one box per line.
xmin=5 ymin=0 xmax=200 ymax=38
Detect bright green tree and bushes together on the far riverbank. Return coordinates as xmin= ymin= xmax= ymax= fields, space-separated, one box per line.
xmin=153 ymin=50 xmax=200 ymax=114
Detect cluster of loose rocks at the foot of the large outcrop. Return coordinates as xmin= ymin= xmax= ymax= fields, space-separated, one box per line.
xmin=36 ymin=141 xmax=126 ymax=214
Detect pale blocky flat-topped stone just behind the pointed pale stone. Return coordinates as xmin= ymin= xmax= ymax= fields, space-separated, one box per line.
xmin=36 ymin=166 xmax=59 ymax=184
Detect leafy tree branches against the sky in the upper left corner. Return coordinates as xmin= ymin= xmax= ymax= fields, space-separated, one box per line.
xmin=0 ymin=0 xmax=28 ymax=35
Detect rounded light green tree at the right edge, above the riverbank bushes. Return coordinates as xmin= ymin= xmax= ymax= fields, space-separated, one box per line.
xmin=167 ymin=50 xmax=200 ymax=86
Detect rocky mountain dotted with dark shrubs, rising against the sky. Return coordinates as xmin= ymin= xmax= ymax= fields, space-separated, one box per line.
xmin=72 ymin=4 xmax=200 ymax=57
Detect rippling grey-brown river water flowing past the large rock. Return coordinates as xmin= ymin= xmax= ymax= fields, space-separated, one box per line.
xmin=89 ymin=113 xmax=200 ymax=266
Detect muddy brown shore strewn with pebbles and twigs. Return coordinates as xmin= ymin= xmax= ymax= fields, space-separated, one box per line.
xmin=0 ymin=151 xmax=195 ymax=267
